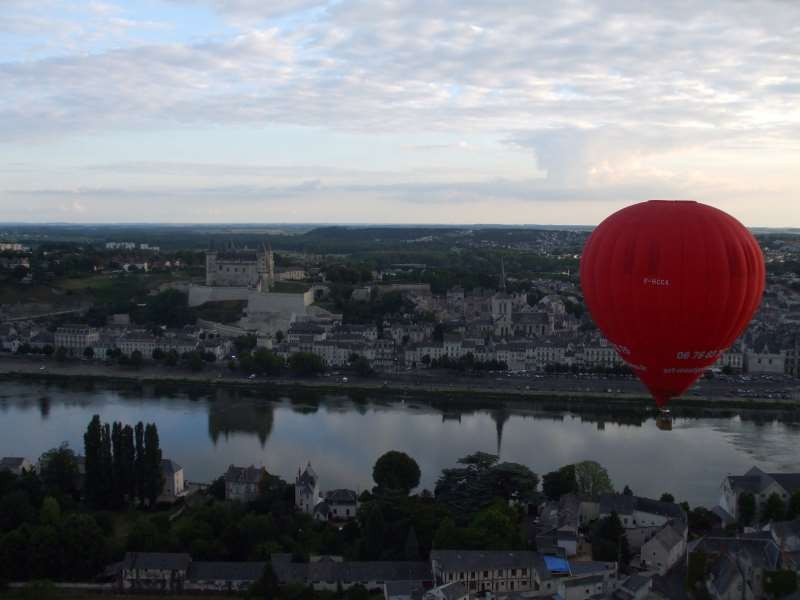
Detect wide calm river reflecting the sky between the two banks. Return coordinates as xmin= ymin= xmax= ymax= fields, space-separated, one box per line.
xmin=0 ymin=382 xmax=800 ymax=507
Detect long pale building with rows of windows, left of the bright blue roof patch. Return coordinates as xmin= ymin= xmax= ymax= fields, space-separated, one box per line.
xmin=431 ymin=550 xmax=550 ymax=594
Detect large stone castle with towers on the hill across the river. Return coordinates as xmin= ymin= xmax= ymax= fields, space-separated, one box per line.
xmin=206 ymin=243 xmax=275 ymax=292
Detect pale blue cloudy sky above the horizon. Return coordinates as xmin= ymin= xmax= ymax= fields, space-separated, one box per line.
xmin=0 ymin=0 xmax=800 ymax=226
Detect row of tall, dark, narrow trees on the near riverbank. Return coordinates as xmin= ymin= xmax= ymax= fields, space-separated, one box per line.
xmin=83 ymin=415 xmax=164 ymax=508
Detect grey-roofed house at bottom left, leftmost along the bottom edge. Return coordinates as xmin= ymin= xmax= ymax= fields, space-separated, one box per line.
xmin=118 ymin=552 xmax=192 ymax=592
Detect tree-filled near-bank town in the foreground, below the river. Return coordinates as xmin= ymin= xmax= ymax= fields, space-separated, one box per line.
xmin=0 ymin=426 xmax=800 ymax=600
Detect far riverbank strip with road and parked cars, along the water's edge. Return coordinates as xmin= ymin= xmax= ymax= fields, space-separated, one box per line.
xmin=0 ymin=356 xmax=800 ymax=414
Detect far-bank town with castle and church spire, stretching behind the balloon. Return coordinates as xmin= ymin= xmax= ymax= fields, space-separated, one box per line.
xmin=0 ymin=228 xmax=800 ymax=398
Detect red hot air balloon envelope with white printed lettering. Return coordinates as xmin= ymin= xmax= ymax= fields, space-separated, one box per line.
xmin=580 ymin=200 xmax=765 ymax=408
